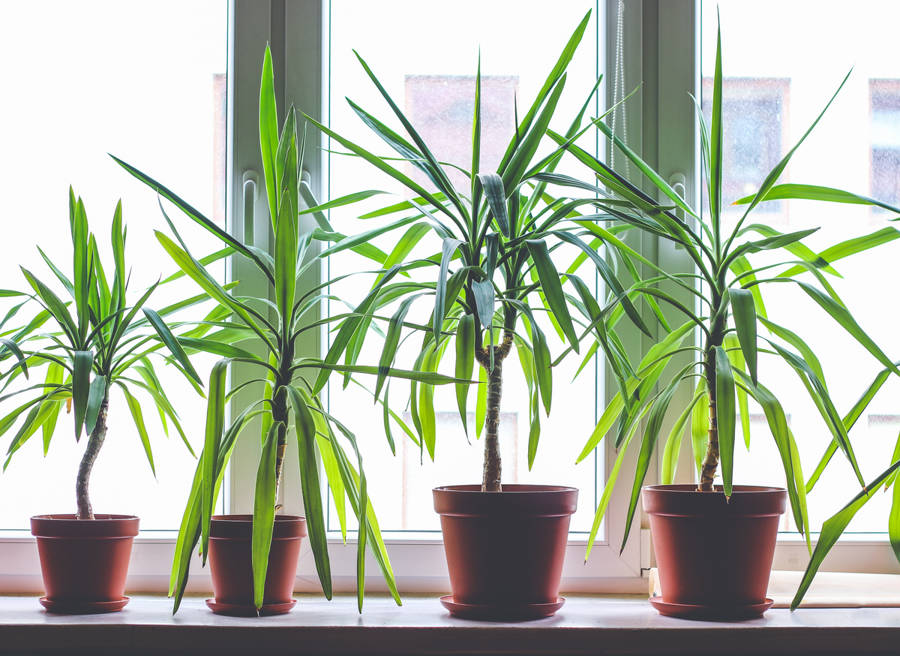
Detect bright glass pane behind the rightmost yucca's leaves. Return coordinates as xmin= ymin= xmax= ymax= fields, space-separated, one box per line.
xmin=702 ymin=0 xmax=900 ymax=532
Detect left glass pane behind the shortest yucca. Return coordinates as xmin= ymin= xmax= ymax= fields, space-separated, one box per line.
xmin=0 ymin=0 xmax=228 ymax=529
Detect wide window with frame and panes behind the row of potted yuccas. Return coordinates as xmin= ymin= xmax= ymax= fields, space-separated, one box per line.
xmin=0 ymin=0 xmax=900 ymax=592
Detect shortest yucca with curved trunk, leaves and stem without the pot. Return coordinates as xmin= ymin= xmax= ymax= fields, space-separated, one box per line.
xmin=0 ymin=188 xmax=206 ymax=519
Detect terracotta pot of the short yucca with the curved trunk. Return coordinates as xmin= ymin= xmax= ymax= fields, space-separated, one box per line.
xmin=31 ymin=515 xmax=140 ymax=614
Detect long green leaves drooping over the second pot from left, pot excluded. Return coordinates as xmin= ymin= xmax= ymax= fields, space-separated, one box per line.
xmin=116 ymin=48 xmax=472 ymax=611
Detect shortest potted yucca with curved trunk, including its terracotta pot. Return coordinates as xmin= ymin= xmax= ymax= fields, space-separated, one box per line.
xmin=0 ymin=189 xmax=212 ymax=613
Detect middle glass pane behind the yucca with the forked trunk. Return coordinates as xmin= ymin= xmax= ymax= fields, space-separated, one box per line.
xmin=327 ymin=0 xmax=603 ymax=532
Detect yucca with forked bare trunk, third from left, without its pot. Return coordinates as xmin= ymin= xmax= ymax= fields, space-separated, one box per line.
xmin=309 ymin=12 xmax=647 ymax=492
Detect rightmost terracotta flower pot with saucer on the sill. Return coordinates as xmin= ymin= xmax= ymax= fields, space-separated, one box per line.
xmin=643 ymin=485 xmax=787 ymax=619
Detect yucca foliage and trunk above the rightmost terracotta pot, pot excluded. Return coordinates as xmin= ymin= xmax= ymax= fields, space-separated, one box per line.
xmin=568 ymin=16 xmax=900 ymax=584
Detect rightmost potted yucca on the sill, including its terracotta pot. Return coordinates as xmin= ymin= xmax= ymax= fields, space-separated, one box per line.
xmin=564 ymin=16 xmax=900 ymax=618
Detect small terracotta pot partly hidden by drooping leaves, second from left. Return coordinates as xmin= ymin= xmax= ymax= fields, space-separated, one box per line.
xmin=206 ymin=515 xmax=306 ymax=616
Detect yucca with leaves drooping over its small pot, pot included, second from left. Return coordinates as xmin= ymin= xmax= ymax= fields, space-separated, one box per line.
xmin=114 ymin=47 xmax=464 ymax=615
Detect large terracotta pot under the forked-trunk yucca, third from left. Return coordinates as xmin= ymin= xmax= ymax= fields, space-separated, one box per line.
xmin=433 ymin=485 xmax=578 ymax=619
